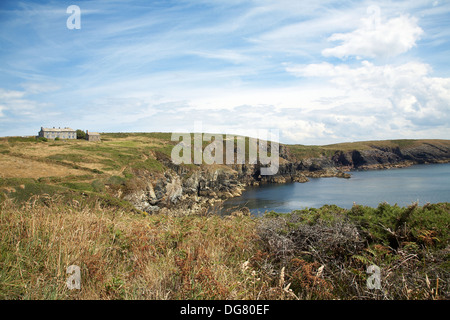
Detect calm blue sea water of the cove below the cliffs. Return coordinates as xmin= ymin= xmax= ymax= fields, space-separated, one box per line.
xmin=222 ymin=163 xmax=450 ymax=215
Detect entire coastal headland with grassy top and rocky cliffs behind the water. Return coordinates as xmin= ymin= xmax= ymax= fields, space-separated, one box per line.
xmin=0 ymin=133 xmax=450 ymax=214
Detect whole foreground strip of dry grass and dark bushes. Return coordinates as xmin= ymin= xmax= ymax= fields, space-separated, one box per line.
xmin=0 ymin=196 xmax=450 ymax=299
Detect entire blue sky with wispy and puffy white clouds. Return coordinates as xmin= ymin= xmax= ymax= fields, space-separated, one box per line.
xmin=0 ymin=0 xmax=450 ymax=144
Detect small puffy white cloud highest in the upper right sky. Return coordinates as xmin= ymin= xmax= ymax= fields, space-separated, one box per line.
xmin=322 ymin=6 xmax=424 ymax=59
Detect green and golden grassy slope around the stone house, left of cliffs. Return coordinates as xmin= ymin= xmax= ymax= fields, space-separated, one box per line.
xmin=0 ymin=133 xmax=176 ymax=206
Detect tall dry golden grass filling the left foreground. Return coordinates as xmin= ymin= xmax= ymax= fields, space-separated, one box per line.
xmin=0 ymin=198 xmax=259 ymax=299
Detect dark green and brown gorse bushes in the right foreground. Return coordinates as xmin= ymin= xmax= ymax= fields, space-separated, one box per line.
xmin=252 ymin=203 xmax=450 ymax=299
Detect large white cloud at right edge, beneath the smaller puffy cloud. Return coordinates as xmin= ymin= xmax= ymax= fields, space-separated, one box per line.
xmin=286 ymin=61 xmax=450 ymax=131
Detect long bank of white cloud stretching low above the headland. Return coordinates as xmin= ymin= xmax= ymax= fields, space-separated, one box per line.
xmin=66 ymin=54 xmax=450 ymax=144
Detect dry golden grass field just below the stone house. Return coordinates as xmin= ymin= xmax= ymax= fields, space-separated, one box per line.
xmin=0 ymin=134 xmax=168 ymax=179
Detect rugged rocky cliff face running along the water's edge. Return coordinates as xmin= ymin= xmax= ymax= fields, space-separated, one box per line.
xmin=124 ymin=141 xmax=450 ymax=214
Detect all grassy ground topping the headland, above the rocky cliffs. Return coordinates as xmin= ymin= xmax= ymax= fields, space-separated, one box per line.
xmin=0 ymin=133 xmax=450 ymax=208
